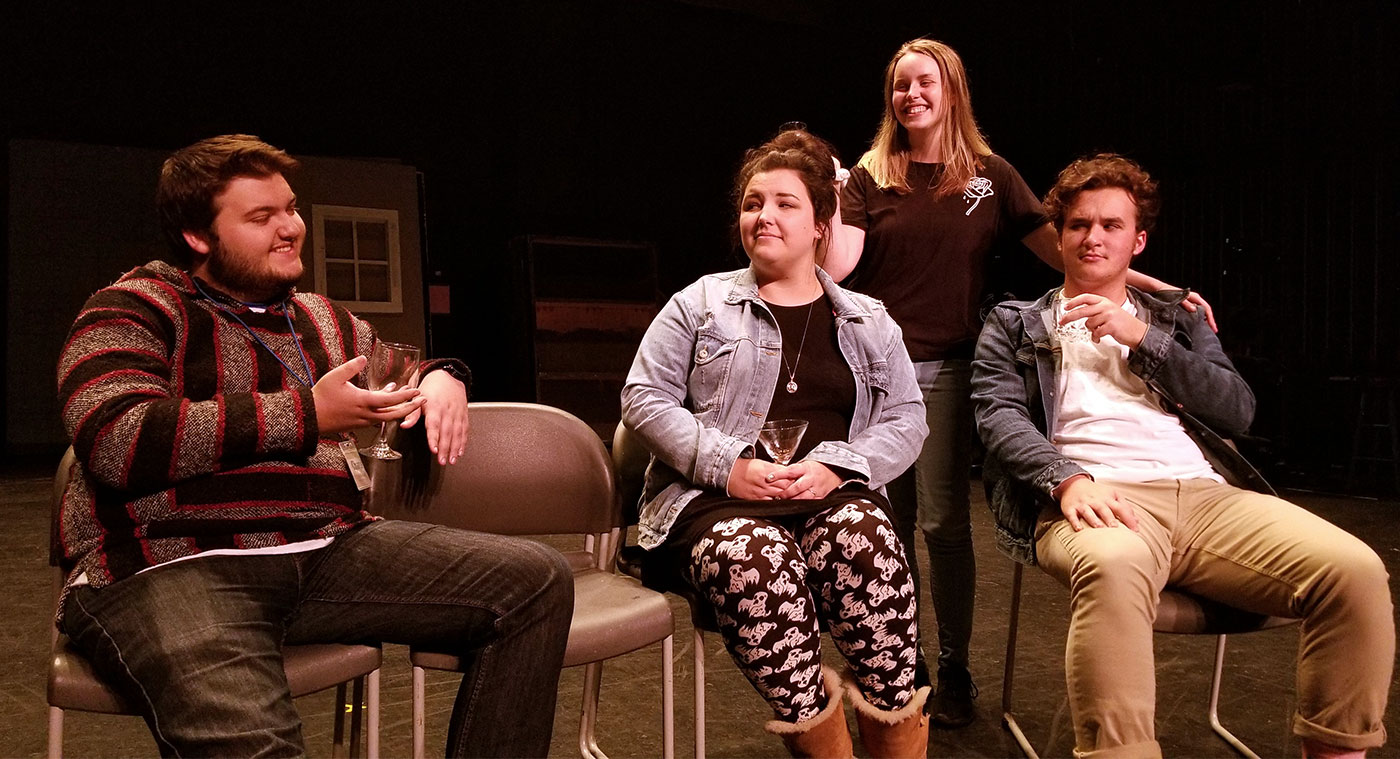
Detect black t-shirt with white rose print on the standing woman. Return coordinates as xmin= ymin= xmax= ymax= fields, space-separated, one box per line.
xmin=841 ymin=155 xmax=1046 ymax=361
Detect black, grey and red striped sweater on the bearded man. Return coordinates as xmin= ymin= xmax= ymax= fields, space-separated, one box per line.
xmin=57 ymin=262 xmax=459 ymax=613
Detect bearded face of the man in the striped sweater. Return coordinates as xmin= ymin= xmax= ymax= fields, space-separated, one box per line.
xmin=185 ymin=174 xmax=307 ymax=302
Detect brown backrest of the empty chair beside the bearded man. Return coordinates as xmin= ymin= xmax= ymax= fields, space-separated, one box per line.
xmin=370 ymin=403 xmax=620 ymax=535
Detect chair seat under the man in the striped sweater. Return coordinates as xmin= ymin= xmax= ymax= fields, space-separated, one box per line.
xmin=49 ymin=636 xmax=382 ymax=714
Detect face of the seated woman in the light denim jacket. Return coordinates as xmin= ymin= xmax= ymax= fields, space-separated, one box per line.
xmin=739 ymin=168 xmax=820 ymax=279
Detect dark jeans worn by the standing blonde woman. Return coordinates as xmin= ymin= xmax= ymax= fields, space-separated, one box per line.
xmin=886 ymin=358 xmax=977 ymax=668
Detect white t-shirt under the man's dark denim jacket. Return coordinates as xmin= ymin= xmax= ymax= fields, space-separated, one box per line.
xmin=1050 ymin=293 xmax=1225 ymax=482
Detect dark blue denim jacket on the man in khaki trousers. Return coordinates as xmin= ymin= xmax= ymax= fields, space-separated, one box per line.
xmin=972 ymin=287 xmax=1274 ymax=564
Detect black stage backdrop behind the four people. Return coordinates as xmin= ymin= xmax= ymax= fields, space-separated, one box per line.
xmin=0 ymin=0 xmax=1400 ymax=487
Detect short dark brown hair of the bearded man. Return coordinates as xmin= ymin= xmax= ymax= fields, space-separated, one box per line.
xmin=155 ymin=134 xmax=298 ymax=267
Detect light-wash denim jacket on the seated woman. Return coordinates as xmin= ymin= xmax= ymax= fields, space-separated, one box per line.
xmin=622 ymin=269 xmax=928 ymax=549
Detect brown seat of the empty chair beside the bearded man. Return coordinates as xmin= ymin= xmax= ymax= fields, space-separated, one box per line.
xmin=409 ymin=569 xmax=675 ymax=671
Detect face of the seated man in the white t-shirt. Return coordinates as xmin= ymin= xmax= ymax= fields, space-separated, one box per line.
xmin=1060 ymin=188 xmax=1147 ymax=302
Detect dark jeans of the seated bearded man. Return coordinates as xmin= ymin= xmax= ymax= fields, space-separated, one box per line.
xmin=63 ymin=521 xmax=574 ymax=756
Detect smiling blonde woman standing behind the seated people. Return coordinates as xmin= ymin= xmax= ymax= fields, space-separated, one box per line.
xmin=823 ymin=39 xmax=1214 ymax=727
